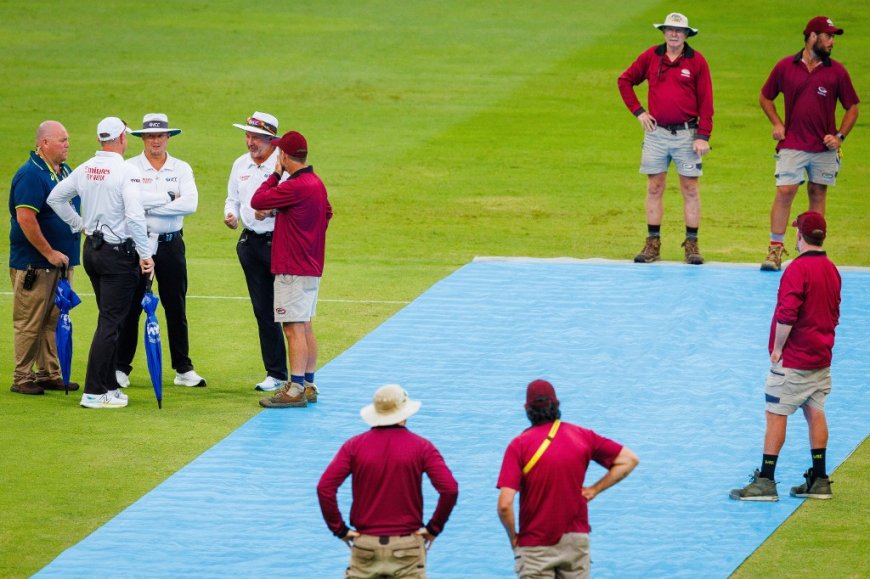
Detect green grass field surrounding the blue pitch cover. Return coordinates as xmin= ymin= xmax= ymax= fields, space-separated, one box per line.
xmin=0 ymin=0 xmax=870 ymax=577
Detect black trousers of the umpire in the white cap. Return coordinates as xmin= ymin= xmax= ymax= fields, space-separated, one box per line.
xmin=84 ymin=237 xmax=141 ymax=394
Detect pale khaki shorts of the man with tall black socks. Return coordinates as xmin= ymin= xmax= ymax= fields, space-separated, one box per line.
xmin=764 ymin=365 xmax=831 ymax=416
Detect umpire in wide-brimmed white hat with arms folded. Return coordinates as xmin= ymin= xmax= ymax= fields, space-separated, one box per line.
xmin=115 ymin=113 xmax=205 ymax=388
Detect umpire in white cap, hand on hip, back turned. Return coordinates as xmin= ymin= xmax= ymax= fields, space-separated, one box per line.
xmin=48 ymin=117 xmax=154 ymax=408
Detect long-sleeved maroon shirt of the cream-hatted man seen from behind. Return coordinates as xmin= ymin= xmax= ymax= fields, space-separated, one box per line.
xmin=317 ymin=425 xmax=459 ymax=537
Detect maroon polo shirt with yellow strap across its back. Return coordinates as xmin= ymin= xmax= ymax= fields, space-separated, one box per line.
xmin=496 ymin=422 xmax=622 ymax=547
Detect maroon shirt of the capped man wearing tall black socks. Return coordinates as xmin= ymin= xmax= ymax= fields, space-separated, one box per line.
xmin=768 ymin=251 xmax=842 ymax=370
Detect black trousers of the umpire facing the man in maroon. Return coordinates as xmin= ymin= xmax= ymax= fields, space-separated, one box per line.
xmin=236 ymin=230 xmax=289 ymax=380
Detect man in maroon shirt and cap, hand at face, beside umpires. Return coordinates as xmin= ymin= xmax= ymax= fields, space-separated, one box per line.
xmin=251 ymin=131 xmax=332 ymax=408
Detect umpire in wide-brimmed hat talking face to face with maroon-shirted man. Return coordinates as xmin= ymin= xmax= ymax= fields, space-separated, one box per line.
xmin=224 ymin=112 xmax=289 ymax=392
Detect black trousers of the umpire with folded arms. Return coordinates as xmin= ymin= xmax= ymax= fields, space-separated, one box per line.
xmin=117 ymin=234 xmax=193 ymax=374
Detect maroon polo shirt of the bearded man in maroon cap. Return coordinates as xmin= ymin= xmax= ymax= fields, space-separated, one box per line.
xmin=761 ymin=51 xmax=860 ymax=153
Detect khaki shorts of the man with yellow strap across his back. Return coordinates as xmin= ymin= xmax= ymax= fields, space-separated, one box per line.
xmin=514 ymin=533 xmax=590 ymax=579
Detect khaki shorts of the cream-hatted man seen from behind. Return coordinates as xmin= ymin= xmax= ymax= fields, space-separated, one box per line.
xmin=344 ymin=533 xmax=426 ymax=579
